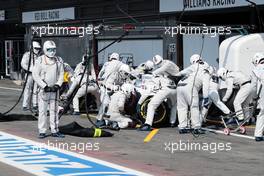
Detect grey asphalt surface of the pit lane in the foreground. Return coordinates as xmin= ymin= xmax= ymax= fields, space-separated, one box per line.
xmin=0 ymin=80 xmax=264 ymax=176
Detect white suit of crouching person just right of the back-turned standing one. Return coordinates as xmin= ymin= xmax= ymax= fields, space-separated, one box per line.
xmin=201 ymin=74 xmax=230 ymax=120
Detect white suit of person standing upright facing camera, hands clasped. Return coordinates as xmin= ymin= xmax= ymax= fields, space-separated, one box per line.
xmin=33 ymin=55 xmax=64 ymax=133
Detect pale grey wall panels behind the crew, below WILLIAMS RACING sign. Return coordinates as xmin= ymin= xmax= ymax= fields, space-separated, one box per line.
xmin=183 ymin=35 xmax=219 ymax=68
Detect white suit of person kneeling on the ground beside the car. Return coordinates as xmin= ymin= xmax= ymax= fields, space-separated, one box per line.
xmin=107 ymin=91 xmax=132 ymax=128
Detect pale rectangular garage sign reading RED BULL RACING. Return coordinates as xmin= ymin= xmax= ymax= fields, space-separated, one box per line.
xmin=22 ymin=7 xmax=75 ymax=23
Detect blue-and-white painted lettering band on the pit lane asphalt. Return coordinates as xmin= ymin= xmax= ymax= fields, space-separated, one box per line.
xmin=0 ymin=131 xmax=152 ymax=176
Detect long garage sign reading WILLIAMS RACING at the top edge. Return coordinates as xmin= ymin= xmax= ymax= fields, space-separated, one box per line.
xmin=160 ymin=0 xmax=264 ymax=12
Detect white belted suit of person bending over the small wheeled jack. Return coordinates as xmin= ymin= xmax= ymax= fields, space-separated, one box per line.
xmin=222 ymin=71 xmax=252 ymax=120
